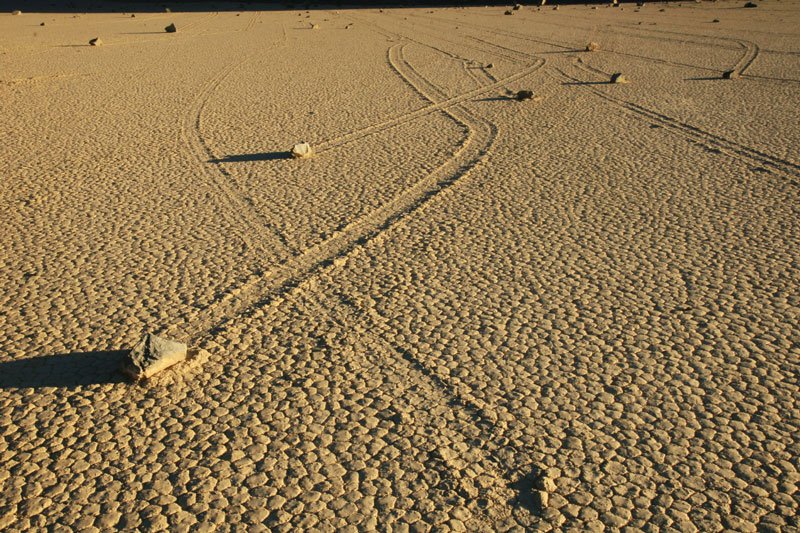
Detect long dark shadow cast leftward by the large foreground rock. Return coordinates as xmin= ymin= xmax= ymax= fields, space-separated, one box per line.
xmin=0 ymin=350 xmax=129 ymax=389
